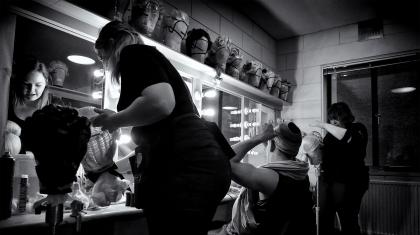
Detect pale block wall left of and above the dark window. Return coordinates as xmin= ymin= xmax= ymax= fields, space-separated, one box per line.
xmin=277 ymin=21 xmax=420 ymax=134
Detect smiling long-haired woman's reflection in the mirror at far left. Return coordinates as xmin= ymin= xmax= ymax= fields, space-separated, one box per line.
xmin=8 ymin=57 xmax=49 ymax=153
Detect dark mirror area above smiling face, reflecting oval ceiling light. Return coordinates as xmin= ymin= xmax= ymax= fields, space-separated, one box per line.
xmin=14 ymin=17 xmax=104 ymax=108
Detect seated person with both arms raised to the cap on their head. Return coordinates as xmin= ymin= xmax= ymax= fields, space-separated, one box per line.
xmin=225 ymin=122 xmax=315 ymax=235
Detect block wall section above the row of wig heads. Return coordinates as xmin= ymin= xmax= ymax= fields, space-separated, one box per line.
xmin=164 ymin=0 xmax=276 ymax=71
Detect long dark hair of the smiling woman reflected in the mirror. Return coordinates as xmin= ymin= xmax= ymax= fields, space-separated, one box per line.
xmin=10 ymin=56 xmax=50 ymax=108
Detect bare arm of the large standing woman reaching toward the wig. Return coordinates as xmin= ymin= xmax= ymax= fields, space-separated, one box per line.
xmin=93 ymin=83 xmax=175 ymax=130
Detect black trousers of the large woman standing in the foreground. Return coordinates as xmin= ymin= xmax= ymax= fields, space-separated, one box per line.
xmin=136 ymin=116 xmax=231 ymax=235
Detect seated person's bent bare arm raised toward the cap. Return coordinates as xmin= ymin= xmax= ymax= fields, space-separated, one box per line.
xmin=230 ymin=125 xmax=278 ymax=196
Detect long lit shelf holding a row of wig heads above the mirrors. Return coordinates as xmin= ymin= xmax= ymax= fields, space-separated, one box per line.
xmin=17 ymin=0 xmax=292 ymax=110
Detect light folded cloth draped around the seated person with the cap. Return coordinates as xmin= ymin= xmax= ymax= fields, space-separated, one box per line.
xmin=219 ymin=160 xmax=309 ymax=235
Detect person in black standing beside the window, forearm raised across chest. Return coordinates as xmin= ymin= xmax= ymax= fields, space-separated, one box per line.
xmin=313 ymin=102 xmax=369 ymax=235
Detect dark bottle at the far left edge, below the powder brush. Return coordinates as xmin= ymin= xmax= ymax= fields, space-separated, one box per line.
xmin=0 ymin=152 xmax=15 ymax=219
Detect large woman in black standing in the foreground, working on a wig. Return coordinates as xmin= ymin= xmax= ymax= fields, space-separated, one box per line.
xmin=92 ymin=21 xmax=233 ymax=235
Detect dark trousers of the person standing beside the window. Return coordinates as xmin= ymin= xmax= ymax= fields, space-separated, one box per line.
xmin=319 ymin=176 xmax=367 ymax=235
